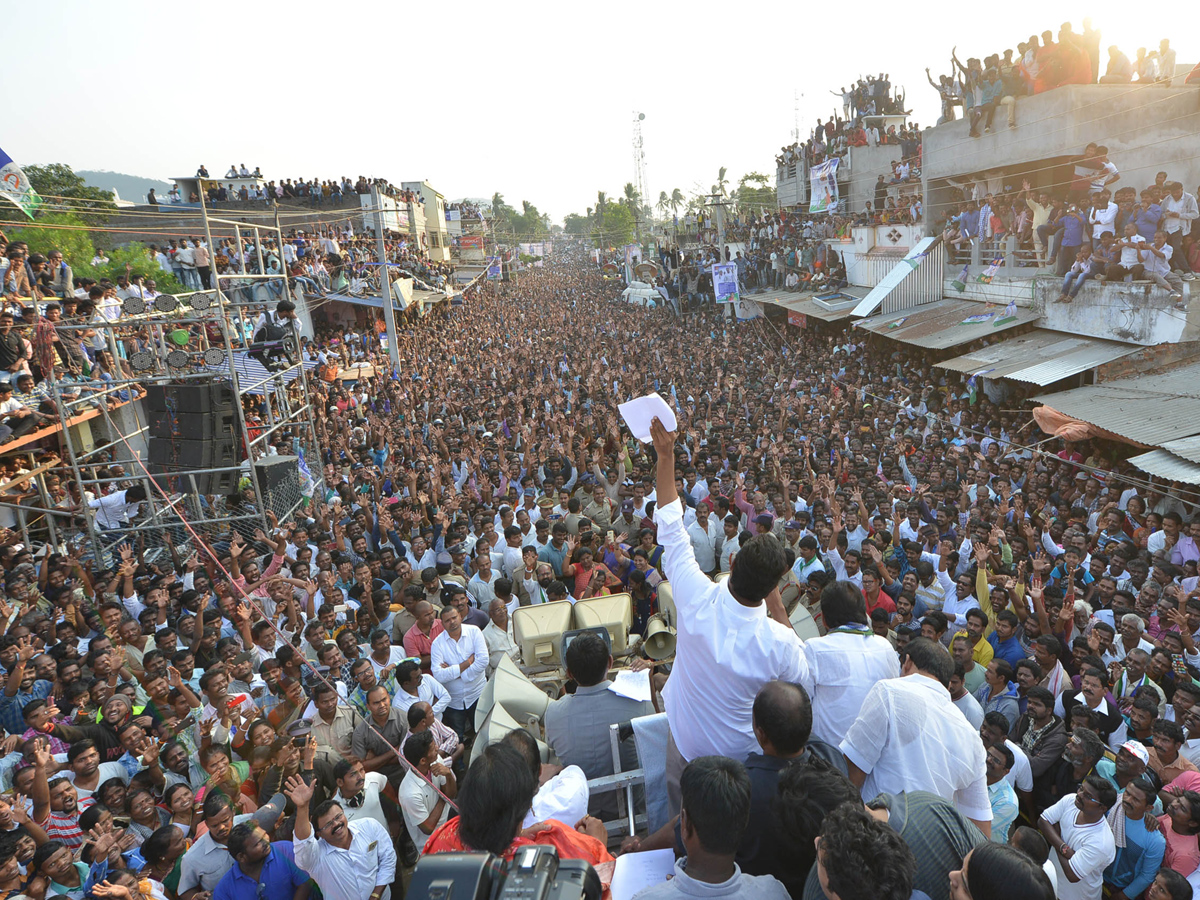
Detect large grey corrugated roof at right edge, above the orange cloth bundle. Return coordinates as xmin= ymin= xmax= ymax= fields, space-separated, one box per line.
xmin=1034 ymin=364 xmax=1200 ymax=446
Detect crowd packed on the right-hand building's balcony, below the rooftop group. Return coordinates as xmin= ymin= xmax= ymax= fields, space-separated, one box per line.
xmin=942 ymin=144 xmax=1200 ymax=301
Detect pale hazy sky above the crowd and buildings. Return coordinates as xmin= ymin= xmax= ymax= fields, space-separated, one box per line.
xmin=14 ymin=0 xmax=1200 ymax=221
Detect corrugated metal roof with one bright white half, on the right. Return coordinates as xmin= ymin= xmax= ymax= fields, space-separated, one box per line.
xmin=934 ymin=328 xmax=1139 ymax=386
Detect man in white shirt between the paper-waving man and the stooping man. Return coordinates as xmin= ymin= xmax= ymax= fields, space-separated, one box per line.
xmin=802 ymin=581 xmax=900 ymax=746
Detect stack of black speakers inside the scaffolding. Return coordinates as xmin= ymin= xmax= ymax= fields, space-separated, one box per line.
xmin=145 ymin=382 xmax=239 ymax=494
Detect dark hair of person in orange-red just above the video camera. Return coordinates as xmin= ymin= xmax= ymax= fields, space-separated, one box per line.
xmin=457 ymin=743 xmax=538 ymax=856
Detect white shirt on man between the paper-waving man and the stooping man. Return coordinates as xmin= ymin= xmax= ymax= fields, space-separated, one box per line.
xmin=802 ymin=625 xmax=900 ymax=746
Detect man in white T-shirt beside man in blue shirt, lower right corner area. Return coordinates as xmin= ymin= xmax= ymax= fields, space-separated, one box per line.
xmin=1038 ymin=773 xmax=1117 ymax=900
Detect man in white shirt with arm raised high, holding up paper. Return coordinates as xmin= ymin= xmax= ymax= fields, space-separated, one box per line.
xmin=650 ymin=419 xmax=806 ymax=815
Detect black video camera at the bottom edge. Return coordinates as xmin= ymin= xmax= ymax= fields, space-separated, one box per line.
xmin=404 ymin=844 xmax=600 ymax=900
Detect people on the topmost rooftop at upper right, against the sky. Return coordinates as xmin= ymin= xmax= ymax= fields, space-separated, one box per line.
xmin=925 ymin=19 xmax=1176 ymax=137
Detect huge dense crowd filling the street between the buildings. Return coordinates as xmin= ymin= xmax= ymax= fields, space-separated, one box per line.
xmin=0 ymin=230 xmax=1200 ymax=900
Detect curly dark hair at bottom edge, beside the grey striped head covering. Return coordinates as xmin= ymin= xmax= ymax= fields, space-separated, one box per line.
xmin=820 ymin=800 xmax=917 ymax=900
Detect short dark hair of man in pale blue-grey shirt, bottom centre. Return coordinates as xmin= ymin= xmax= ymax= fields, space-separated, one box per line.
xmin=679 ymin=756 xmax=750 ymax=857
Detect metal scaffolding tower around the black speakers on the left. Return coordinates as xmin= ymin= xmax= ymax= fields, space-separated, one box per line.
xmin=0 ymin=209 xmax=320 ymax=565
